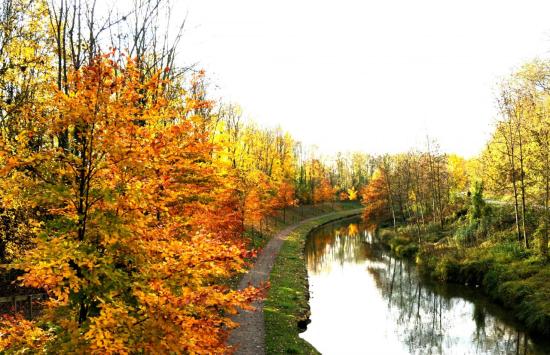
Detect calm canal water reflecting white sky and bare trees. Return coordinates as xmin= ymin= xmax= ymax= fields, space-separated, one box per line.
xmin=301 ymin=219 xmax=550 ymax=355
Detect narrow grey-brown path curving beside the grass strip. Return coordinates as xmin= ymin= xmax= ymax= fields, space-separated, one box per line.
xmin=229 ymin=212 xmax=362 ymax=355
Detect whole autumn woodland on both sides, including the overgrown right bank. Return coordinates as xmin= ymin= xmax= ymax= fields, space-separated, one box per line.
xmin=0 ymin=0 xmax=550 ymax=354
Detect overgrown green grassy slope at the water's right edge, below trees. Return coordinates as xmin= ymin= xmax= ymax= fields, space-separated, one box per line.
xmin=378 ymin=226 xmax=550 ymax=337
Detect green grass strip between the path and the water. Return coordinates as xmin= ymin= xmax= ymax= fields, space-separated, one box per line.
xmin=264 ymin=210 xmax=357 ymax=354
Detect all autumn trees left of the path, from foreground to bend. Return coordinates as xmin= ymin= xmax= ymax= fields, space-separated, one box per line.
xmin=0 ymin=0 xmax=373 ymax=353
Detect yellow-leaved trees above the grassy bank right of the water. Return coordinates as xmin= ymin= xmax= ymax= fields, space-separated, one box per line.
xmin=361 ymin=60 xmax=550 ymax=256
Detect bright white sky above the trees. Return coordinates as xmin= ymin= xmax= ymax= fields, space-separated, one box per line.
xmin=172 ymin=0 xmax=550 ymax=156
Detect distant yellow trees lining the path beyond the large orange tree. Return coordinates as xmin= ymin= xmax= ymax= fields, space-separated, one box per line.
xmin=213 ymin=104 xmax=373 ymax=224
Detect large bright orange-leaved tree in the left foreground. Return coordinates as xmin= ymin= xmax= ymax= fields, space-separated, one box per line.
xmin=0 ymin=54 xmax=255 ymax=354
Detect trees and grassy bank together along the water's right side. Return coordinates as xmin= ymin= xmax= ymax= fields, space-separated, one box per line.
xmin=361 ymin=60 xmax=550 ymax=335
